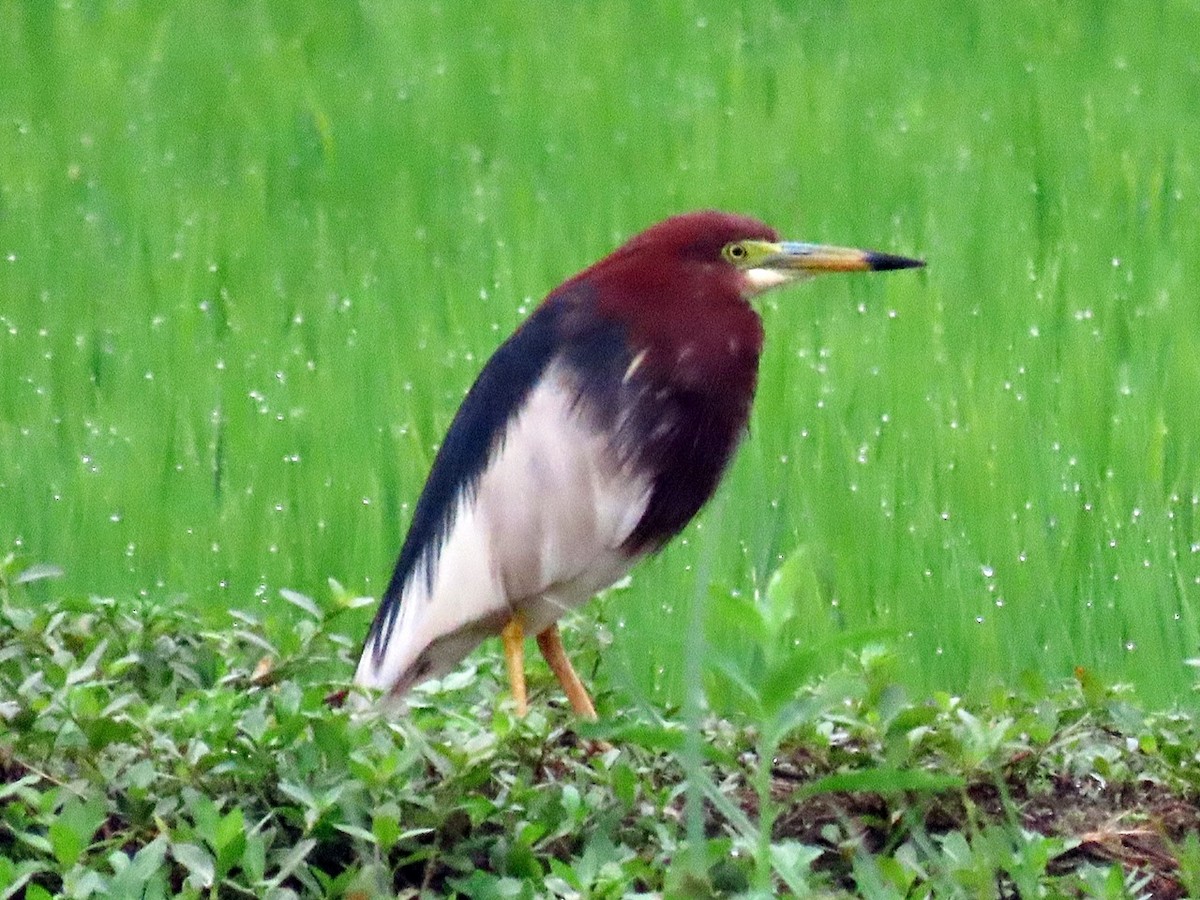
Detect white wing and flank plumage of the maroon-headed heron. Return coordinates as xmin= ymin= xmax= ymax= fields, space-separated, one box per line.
xmin=354 ymin=367 xmax=649 ymax=695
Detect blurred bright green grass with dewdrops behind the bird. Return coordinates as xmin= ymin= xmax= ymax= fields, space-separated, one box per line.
xmin=0 ymin=0 xmax=1200 ymax=703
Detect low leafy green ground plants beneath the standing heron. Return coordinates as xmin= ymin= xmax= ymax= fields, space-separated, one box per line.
xmin=0 ymin=559 xmax=1200 ymax=900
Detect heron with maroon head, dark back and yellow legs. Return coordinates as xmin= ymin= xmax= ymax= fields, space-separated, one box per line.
xmin=354 ymin=210 xmax=924 ymax=719
